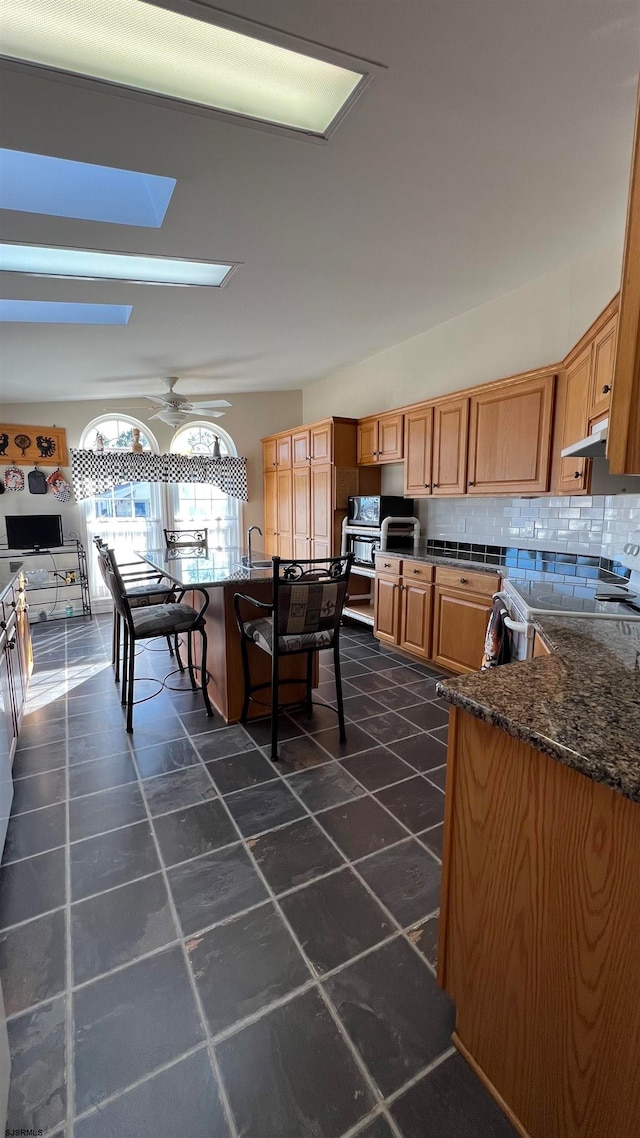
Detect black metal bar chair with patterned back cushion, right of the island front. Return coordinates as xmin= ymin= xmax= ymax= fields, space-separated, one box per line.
xmin=233 ymin=553 xmax=353 ymax=762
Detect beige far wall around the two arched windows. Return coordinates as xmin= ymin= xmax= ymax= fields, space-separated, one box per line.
xmin=0 ymin=391 xmax=302 ymax=542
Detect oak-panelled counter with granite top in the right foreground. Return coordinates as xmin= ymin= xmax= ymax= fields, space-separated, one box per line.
xmin=438 ymin=617 xmax=640 ymax=1138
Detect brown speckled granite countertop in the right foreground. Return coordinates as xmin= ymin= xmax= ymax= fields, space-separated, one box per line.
xmin=437 ymin=616 xmax=640 ymax=802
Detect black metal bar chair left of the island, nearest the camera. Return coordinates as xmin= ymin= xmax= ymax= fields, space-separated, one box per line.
xmin=98 ymin=546 xmax=213 ymax=732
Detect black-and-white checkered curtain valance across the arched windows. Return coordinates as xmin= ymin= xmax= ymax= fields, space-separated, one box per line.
xmin=71 ymin=450 xmax=248 ymax=502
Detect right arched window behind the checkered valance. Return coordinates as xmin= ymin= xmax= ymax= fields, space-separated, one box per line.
xmin=170 ymin=421 xmax=240 ymax=549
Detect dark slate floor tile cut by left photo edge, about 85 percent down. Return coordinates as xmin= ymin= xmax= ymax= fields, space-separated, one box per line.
xmin=0 ymin=909 xmax=66 ymax=1015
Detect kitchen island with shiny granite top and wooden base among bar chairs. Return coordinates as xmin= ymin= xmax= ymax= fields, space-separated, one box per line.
xmin=138 ymin=546 xmax=318 ymax=723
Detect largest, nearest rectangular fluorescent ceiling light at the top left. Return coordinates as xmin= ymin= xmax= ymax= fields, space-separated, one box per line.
xmin=2 ymin=0 xmax=366 ymax=135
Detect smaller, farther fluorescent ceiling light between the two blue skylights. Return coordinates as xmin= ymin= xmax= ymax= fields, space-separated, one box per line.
xmin=0 ymin=244 xmax=236 ymax=288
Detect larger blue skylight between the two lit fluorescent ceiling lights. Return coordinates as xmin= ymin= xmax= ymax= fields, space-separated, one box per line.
xmin=0 ymin=148 xmax=175 ymax=229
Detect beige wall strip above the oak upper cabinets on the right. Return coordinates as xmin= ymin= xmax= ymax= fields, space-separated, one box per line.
xmin=303 ymin=247 xmax=622 ymax=422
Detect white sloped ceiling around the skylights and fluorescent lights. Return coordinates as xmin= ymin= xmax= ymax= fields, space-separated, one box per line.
xmin=0 ymin=0 xmax=640 ymax=401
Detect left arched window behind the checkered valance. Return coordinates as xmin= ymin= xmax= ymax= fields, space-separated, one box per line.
xmin=80 ymin=414 xmax=165 ymax=600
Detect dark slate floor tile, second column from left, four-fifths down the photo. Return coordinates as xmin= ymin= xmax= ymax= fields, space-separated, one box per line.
xmin=71 ymin=873 xmax=178 ymax=984
